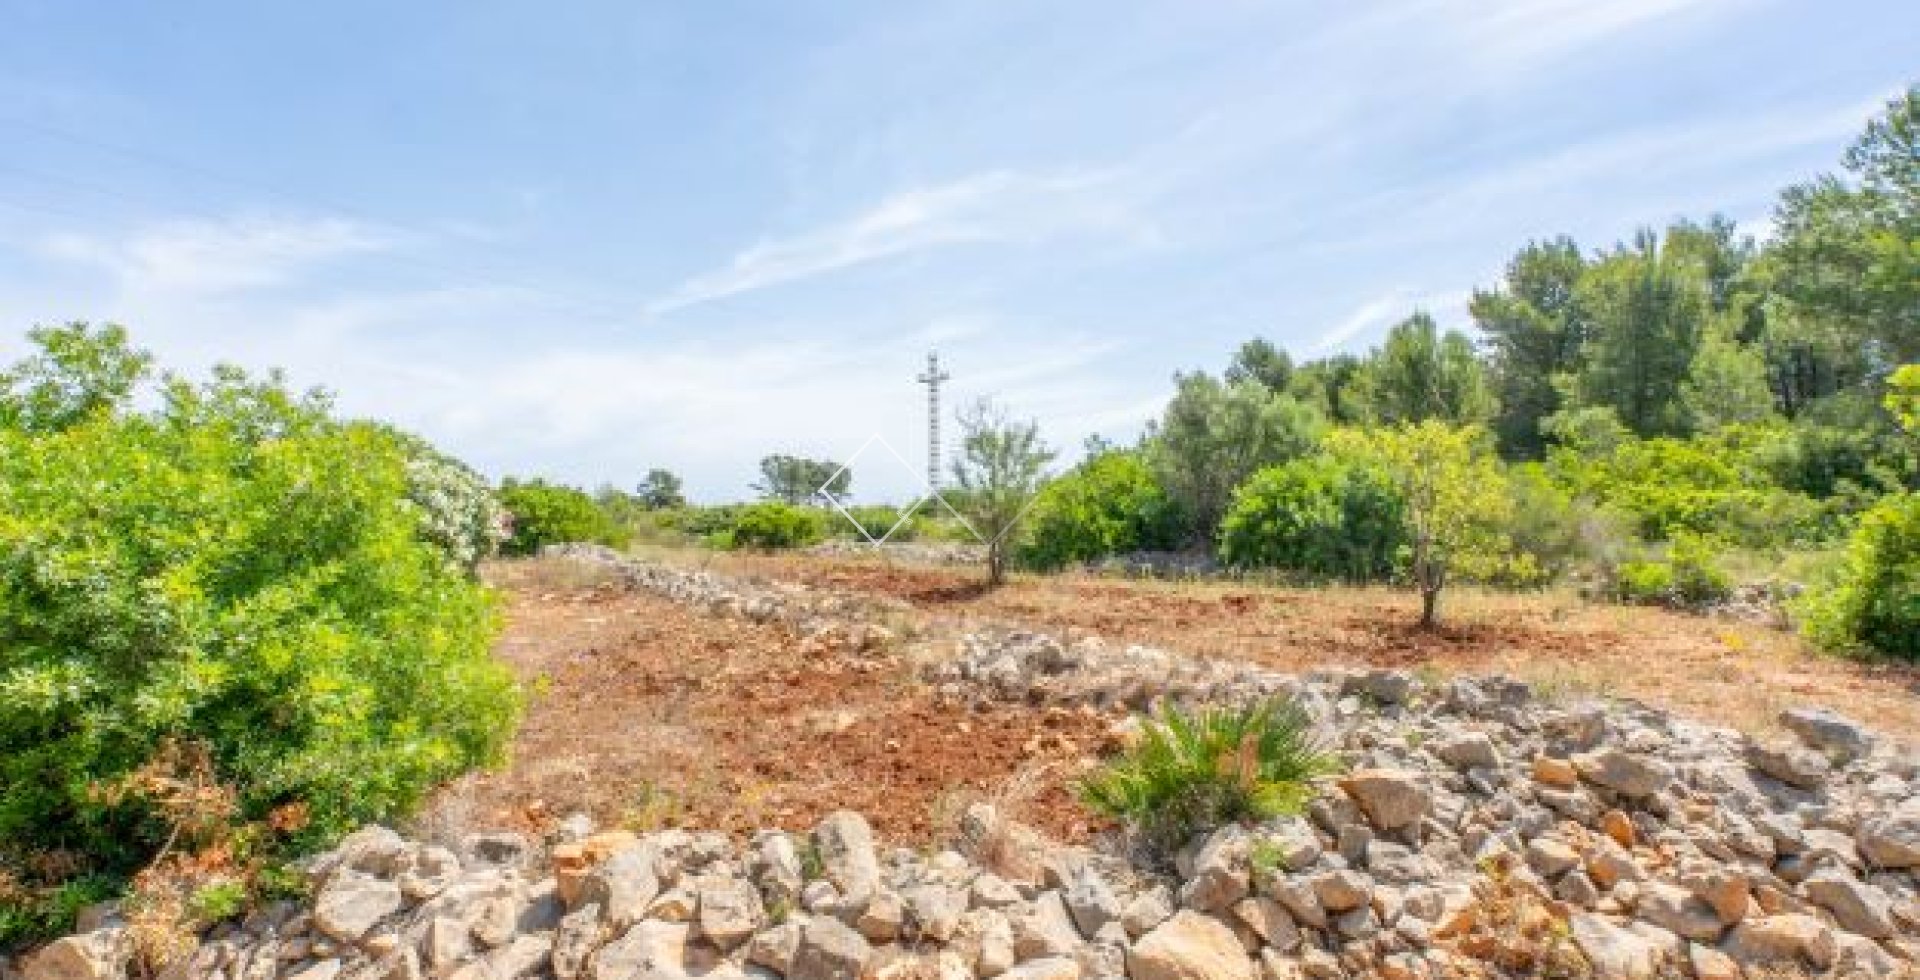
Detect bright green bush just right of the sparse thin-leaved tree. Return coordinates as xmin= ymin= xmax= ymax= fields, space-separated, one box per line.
xmin=1020 ymin=449 xmax=1182 ymax=571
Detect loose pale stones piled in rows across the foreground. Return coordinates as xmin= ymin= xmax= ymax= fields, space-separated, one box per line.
xmin=17 ymin=550 xmax=1920 ymax=980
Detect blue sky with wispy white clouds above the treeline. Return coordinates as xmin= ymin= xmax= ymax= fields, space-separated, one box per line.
xmin=0 ymin=0 xmax=1920 ymax=500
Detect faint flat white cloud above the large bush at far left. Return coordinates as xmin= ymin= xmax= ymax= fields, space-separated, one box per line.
xmin=40 ymin=217 xmax=394 ymax=294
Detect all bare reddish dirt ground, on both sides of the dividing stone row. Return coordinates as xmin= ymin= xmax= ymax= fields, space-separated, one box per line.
xmin=445 ymin=551 xmax=1920 ymax=844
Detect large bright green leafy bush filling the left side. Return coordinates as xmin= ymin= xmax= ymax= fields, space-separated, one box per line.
xmin=0 ymin=332 xmax=516 ymax=874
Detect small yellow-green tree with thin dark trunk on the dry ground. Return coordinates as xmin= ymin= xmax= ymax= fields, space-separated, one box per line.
xmin=1336 ymin=421 xmax=1524 ymax=628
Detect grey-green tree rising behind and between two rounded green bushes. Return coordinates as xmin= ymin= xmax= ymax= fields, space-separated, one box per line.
xmin=1148 ymin=375 xmax=1325 ymax=540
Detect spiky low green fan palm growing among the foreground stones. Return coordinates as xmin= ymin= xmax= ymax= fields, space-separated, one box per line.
xmin=1079 ymin=698 xmax=1334 ymax=853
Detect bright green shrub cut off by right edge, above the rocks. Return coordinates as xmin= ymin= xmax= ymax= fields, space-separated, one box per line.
xmin=1803 ymin=494 xmax=1920 ymax=661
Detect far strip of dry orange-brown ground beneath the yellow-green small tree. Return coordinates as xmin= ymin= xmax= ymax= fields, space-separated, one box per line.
xmin=706 ymin=551 xmax=1920 ymax=742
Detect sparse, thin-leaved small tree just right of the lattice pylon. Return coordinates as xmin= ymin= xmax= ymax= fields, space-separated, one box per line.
xmin=952 ymin=400 xmax=1054 ymax=586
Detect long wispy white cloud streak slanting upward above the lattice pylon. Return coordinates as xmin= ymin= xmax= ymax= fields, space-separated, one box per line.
xmin=649 ymin=171 xmax=1131 ymax=315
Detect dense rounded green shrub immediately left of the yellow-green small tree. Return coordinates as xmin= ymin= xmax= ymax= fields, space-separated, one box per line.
xmin=1219 ymin=455 xmax=1405 ymax=582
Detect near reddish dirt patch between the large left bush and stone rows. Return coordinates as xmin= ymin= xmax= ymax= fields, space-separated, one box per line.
xmin=443 ymin=561 xmax=1114 ymax=842
